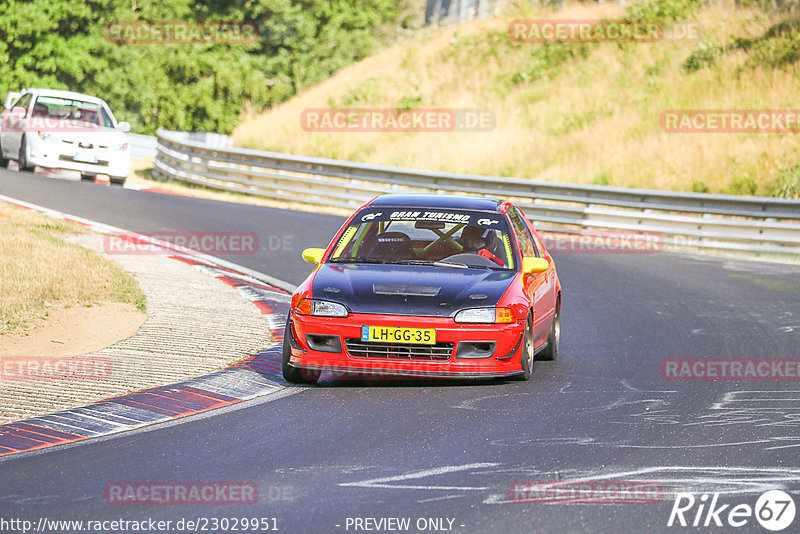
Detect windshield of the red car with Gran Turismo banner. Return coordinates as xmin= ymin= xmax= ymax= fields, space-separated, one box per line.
xmin=328 ymin=208 xmax=515 ymax=269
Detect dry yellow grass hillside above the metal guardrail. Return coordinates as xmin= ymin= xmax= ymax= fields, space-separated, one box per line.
xmin=234 ymin=0 xmax=800 ymax=194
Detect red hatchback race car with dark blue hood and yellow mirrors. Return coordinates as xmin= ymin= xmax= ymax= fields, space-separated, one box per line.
xmin=283 ymin=195 xmax=561 ymax=383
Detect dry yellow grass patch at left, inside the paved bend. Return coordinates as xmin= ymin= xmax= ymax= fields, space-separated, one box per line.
xmin=0 ymin=203 xmax=145 ymax=335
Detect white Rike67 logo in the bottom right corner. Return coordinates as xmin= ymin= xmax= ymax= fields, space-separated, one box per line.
xmin=667 ymin=490 xmax=795 ymax=532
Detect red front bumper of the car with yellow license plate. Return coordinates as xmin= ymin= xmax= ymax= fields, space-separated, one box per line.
xmin=290 ymin=314 xmax=525 ymax=378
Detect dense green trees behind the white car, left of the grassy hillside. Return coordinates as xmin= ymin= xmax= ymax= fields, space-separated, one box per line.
xmin=0 ymin=0 xmax=414 ymax=133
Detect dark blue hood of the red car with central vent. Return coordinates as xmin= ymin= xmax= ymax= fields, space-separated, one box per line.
xmin=312 ymin=263 xmax=516 ymax=317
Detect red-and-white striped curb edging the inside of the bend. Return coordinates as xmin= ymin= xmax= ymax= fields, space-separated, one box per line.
xmin=0 ymin=199 xmax=289 ymax=456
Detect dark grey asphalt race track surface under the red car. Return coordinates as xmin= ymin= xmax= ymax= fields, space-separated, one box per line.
xmin=0 ymin=170 xmax=800 ymax=533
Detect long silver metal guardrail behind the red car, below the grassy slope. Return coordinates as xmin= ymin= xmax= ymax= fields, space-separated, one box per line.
xmin=154 ymin=130 xmax=800 ymax=255
